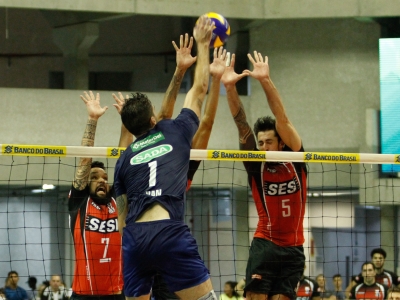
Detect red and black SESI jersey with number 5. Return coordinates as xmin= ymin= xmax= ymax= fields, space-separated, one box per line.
xmin=241 ymin=136 xmax=307 ymax=247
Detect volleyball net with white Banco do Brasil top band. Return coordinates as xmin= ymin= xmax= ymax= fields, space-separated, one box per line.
xmin=0 ymin=144 xmax=400 ymax=294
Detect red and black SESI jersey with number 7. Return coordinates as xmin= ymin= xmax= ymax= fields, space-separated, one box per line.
xmin=68 ymin=186 xmax=123 ymax=296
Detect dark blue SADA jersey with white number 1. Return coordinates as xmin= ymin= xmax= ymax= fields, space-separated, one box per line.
xmin=114 ymin=108 xmax=199 ymax=224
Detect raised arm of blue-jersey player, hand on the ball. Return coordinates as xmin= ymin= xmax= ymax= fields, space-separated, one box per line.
xmin=183 ymin=15 xmax=212 ymax=118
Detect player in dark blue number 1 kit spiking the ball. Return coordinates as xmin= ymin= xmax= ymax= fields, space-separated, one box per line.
xmin=114 ymin=16 xmax=216 ymax=300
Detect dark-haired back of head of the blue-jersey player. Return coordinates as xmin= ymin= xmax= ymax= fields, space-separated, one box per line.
xmin=121 ymin=92 xmax=154 ymax=136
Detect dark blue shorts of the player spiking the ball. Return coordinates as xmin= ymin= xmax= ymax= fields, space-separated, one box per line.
xmin=122 ymin=220 xmax=210 ymax=297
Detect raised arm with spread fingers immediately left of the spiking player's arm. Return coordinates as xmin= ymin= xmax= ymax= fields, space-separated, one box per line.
xmin=157 ymin=33 xmax=197 ymax=121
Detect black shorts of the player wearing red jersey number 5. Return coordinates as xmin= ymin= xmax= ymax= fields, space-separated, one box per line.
xmin=244 ymin=238 xmax=305 ymax=299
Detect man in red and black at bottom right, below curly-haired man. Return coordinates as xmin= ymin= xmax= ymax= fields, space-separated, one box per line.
xmin=349 ymin=262 xmax=387 ymax=300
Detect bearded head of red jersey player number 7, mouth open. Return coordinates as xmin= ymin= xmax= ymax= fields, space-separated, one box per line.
xmin=89 ymin=161 xmax=110 ymax=200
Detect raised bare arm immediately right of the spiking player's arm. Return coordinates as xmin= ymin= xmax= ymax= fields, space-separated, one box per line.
xmin=192 ymin=47 xmax=227 ymax=149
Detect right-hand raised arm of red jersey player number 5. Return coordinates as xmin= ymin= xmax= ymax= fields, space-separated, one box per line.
xmin=244 ymin=51 xmax=301 ymax=151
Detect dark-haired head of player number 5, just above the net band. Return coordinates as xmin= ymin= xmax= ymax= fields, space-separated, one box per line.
xmin=254 ymin=116 xmax=285 ymax=151
